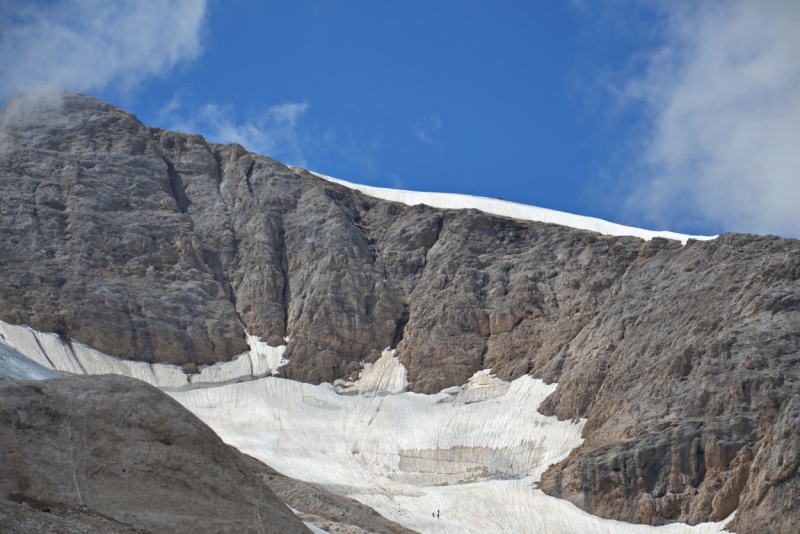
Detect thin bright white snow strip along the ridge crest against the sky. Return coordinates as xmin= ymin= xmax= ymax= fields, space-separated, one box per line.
xmin=309 ymin=171 xmax=717 ymax=245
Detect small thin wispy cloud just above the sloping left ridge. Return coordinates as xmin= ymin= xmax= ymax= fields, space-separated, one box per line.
xmin=159 ymin=98 xmax=310 ymax=166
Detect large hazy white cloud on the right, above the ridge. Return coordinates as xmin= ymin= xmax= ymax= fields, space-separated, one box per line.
xmin=625 ymin=0 xmax=800 ymax=236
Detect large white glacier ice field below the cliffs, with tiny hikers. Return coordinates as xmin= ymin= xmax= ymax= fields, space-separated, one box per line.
xmin=170 ymin=351 xmax=726 ymax=534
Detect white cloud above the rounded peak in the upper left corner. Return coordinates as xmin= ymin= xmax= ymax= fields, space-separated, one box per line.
xmin=0 ymin=0 xmax=206 ymax=98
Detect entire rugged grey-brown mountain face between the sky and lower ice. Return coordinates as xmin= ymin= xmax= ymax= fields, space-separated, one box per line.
xmin=0 ymin=93 xmax=800 ymax=534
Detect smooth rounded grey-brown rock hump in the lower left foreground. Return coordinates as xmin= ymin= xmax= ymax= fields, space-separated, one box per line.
xmin=0 ymin=375 xmax=310 ymax=534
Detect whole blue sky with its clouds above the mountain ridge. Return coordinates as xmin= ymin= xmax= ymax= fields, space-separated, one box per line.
xmin=0 ymin=0 xmax=800 ymax=236
